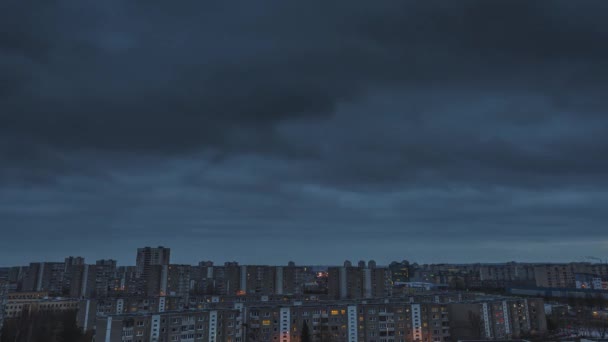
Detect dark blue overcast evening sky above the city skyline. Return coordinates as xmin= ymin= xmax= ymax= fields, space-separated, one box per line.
xmin=0 ymin=0 xmax=608 ymax=266
